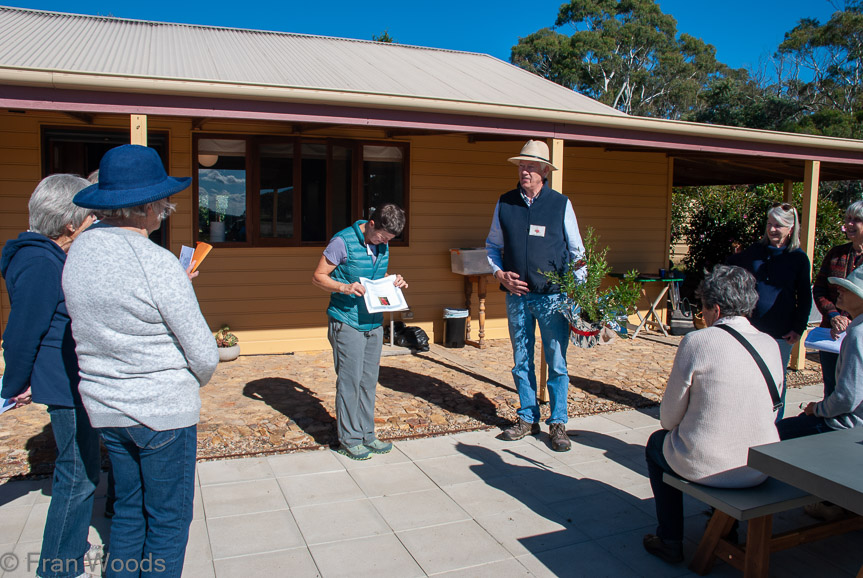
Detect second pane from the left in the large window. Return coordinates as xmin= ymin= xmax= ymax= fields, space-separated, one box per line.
xmin=260 ymin=143 xmax=294 ymax=239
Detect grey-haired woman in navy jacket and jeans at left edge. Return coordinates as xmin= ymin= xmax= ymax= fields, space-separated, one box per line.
xmin=0 ymin=175 xmax=99 ymax=578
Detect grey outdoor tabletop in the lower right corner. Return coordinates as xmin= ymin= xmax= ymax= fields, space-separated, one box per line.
xmin=748 ymin=428 xmax=863 ymax=515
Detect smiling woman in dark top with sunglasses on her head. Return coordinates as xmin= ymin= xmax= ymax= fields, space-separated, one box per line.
xmin=728 ymin=203 xmax=812 ymax=419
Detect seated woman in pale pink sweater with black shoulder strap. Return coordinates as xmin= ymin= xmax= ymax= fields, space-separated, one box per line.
xmin=643 ymin=265 xmax=784 ymax=563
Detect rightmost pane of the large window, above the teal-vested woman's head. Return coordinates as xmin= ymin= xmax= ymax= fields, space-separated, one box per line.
xmin=363 ymin=145 xmax=405 ymax=218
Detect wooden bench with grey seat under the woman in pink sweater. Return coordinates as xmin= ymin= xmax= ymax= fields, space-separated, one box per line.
xmin=662 ymin=473 xmax=863 ymax=578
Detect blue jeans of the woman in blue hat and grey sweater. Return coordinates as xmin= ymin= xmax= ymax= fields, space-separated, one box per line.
xmin=100 ymin=425 xmax=198 ymax=578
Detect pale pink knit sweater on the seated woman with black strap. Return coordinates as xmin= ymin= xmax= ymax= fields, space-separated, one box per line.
xmin=660 ymin=317 xmax=783 ymax=488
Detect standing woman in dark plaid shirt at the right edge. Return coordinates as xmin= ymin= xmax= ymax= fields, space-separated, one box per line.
xmin=812 ymin=201 xmax=863 ymax=399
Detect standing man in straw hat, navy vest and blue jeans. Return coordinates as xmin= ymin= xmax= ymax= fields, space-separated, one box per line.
xmin=485 ymin=140 xmax=584 ymax=452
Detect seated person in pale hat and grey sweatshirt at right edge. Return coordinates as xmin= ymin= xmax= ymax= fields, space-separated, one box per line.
xmin=776 ymin=267 xmax=863 ymax=440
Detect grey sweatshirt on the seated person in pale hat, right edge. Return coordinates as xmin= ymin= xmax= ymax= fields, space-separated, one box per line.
xmin=815 ymin=315 xmax=863 ymax=429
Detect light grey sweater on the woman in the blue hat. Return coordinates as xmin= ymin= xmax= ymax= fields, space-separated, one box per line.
xmin=63 ymin=224 xmax=219 ymax=431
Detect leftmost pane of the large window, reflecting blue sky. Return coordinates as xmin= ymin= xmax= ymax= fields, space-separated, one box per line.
xmin=198 ymin=139 xmax=246 ymax=243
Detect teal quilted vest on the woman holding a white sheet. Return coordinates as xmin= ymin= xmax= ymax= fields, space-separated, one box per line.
xmin=327 ymin=221 xmax=390 ymax=331
